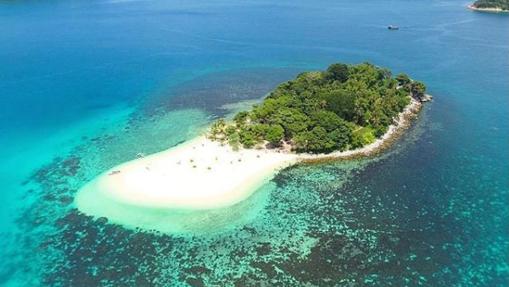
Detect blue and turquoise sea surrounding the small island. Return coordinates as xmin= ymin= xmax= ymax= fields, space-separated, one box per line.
xmin=0 ymin=0 xmax=509 ymax=286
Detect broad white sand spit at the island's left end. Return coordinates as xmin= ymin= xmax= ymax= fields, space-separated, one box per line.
xmin=76 ymin=137 xmax=297 ymax=213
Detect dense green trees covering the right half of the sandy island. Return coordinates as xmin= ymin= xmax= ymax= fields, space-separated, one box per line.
xmin=209 ymin=63 xmax=426 ymax=153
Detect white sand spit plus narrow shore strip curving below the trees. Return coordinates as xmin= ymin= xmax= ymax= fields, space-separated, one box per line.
xmin=74 ymin=100 xmax=422 ymax=226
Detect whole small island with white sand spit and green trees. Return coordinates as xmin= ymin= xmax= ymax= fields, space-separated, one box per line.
xmin=75 ymin=63 xmax=431 ymax=234
